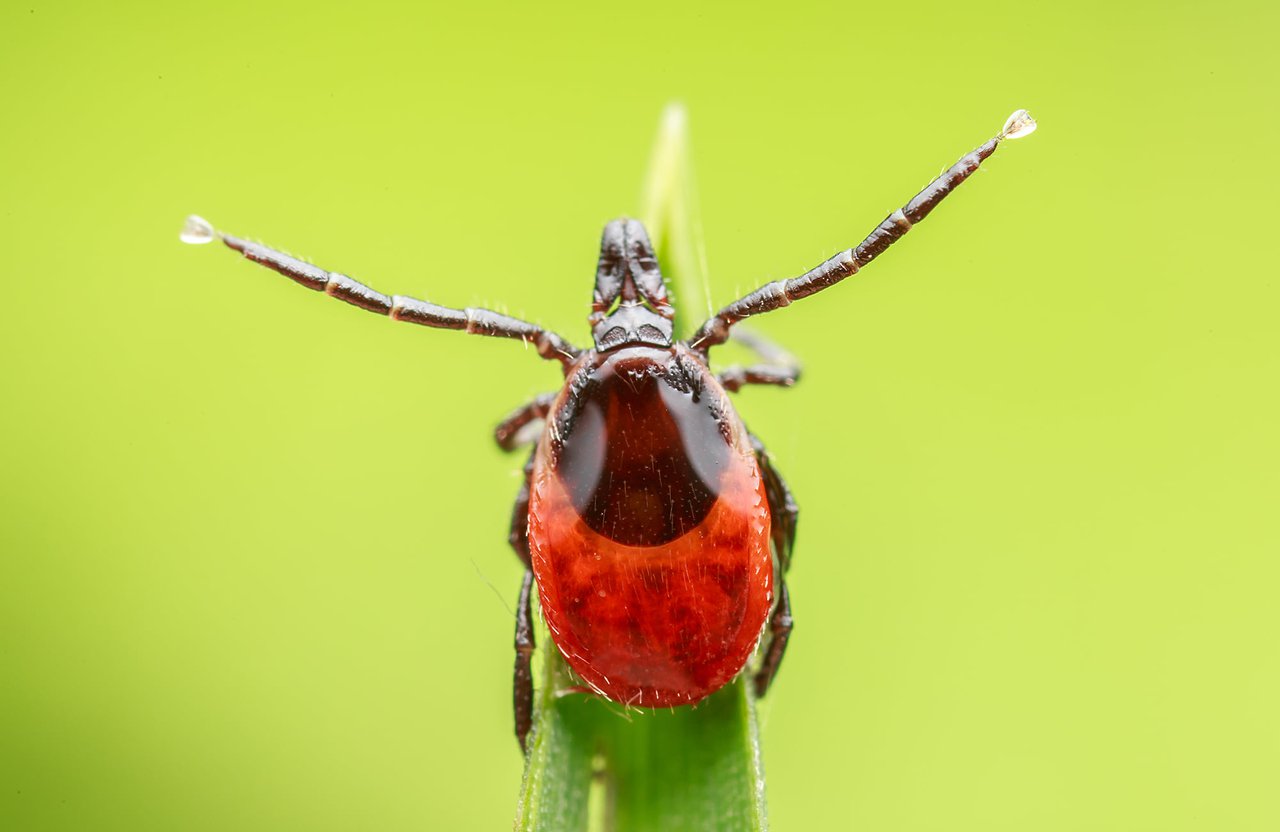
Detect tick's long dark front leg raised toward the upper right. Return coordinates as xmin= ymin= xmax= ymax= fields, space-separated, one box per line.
xmin=689 ymin=110 xmax=1036 ymax=352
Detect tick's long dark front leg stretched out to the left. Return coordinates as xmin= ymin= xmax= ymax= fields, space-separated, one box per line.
xmin=188 ymin=218 xmax=580 ymax=370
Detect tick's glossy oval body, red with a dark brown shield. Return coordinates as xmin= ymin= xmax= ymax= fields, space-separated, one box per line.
xmin=529 ymin=347 xmax=773 ymax=707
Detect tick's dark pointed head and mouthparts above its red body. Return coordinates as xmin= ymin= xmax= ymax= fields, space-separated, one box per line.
xmin=588 ymin=219 xmax=676 ymax=352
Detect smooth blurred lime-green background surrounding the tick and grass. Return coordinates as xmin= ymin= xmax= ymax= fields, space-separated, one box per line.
xmin=0 ymin=0 xmax=1280 ymax=831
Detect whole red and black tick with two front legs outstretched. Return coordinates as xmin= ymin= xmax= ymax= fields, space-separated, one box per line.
xmin=182 ymin=110 xmax=1036 ymax=748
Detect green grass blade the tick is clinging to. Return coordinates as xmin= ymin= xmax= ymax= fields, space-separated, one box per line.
xmin=516 ymin=105 xmax=768 ymax=832
